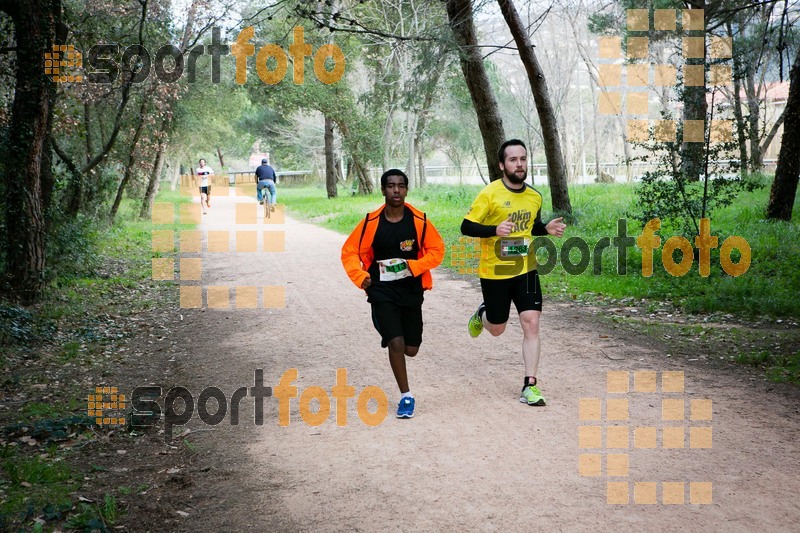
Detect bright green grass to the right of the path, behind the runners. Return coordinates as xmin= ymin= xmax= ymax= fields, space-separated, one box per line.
xmin=280 ymin=184 xmax=800 ymax=317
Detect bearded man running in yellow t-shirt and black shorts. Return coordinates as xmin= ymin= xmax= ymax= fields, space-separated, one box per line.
xmin=461 ymin=139 xmax=567 ymax=405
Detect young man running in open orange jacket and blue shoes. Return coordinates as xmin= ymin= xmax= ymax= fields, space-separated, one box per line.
xmin=342 ymin=169 xmax=444 ymax=418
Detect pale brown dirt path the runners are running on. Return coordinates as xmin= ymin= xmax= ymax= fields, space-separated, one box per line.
xmin=153 ymin=193 xmax=800 ymax=531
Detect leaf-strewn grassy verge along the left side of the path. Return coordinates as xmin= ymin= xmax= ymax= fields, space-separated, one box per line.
xmin=0 ymin=186 xmax=194 ymax=531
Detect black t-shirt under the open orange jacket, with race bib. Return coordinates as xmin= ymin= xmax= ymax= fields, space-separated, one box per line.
xmin=367 ymin=208 xmax=423 ymax=306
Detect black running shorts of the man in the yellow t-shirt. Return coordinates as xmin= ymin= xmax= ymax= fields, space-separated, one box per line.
xmin=481 ymin=270 xmax=542 ymax=324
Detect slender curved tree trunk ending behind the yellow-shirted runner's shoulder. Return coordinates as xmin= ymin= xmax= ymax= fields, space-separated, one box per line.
xmin=498 ymin=0 xmax=572 ymax=213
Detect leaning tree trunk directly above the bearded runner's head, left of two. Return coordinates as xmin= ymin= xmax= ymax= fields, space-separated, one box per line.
xmin=443 ymin=0 xmax=505 ymax=181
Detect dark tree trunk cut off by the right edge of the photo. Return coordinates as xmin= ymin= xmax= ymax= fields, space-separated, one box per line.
xmin=767 ymin=49 xmax=800 ymax=221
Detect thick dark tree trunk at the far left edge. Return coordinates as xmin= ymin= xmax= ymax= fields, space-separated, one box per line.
xmin=0 ymin=0 xmax=61 ymax=303
